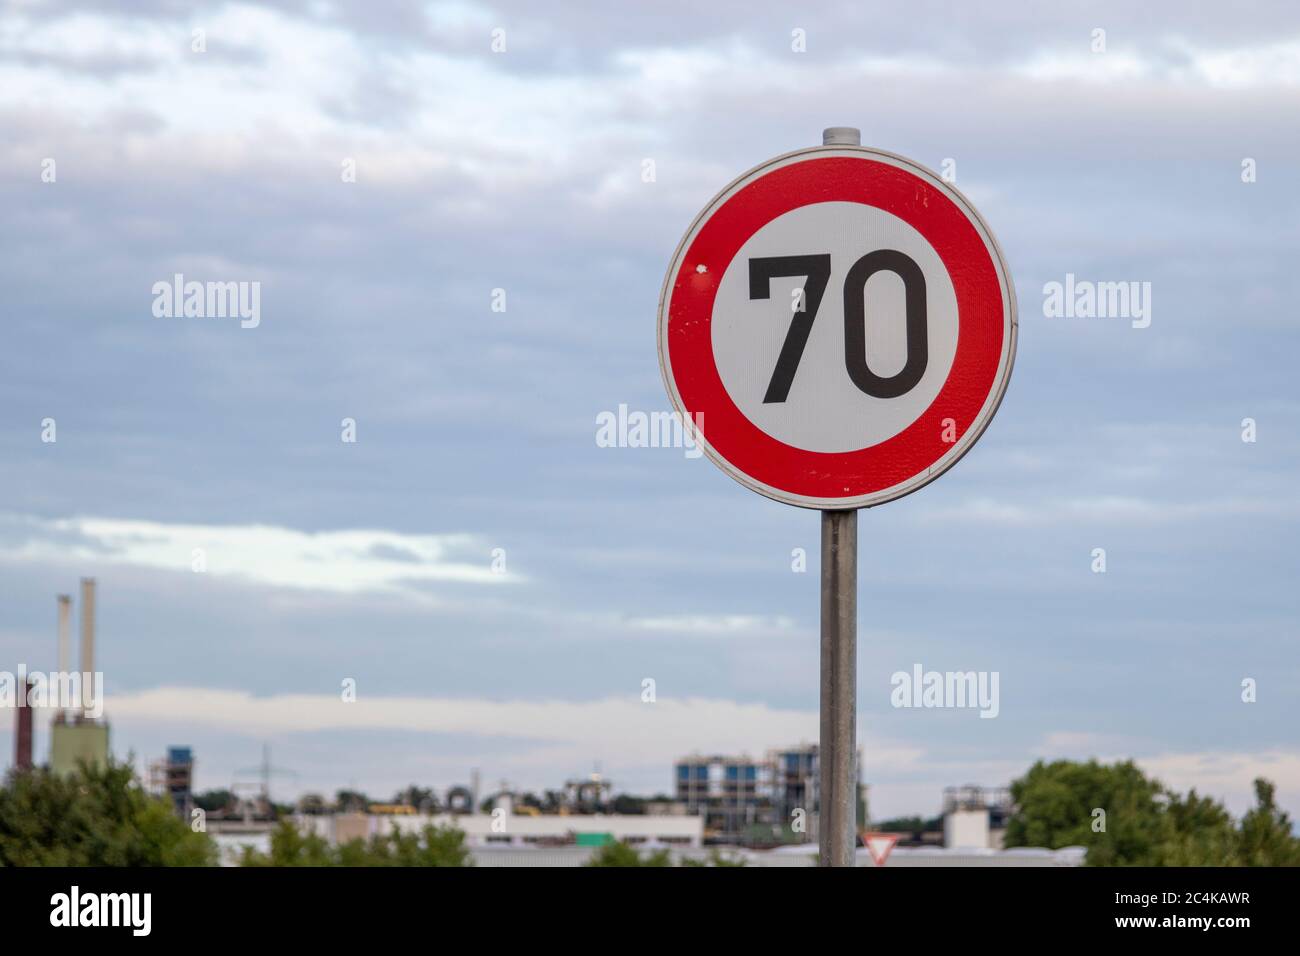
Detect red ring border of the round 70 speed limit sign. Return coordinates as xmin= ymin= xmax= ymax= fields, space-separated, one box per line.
xmin=660 ymin=150 xmax=1015 ymax=506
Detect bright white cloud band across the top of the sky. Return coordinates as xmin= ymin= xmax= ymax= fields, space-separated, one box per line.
xmin=0 ymin=4 xmax=1300 ymax=200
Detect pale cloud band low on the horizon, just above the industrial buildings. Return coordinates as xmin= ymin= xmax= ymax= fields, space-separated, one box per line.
xmin=0 ymin=685 xmax=1300 ymax=819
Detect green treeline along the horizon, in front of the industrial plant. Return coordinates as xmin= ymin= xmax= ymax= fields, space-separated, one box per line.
xmin=0 ymin=761 xmax=1300 ymax=866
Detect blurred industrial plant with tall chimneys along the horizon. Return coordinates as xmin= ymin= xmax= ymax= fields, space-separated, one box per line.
xmin=5 ymin=578 xmax=1082 ymax=866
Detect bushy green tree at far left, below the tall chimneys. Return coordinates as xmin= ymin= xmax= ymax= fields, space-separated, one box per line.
xmin=0 ymin=758 xmax=217 ymax=866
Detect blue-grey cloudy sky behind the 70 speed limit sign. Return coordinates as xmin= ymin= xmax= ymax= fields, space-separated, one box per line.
xmin=0 ymin=0 xmax=1300 ymax=818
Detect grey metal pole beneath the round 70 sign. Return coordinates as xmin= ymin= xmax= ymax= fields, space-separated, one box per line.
xmin=818 ymin=511 xmax=858 ymax=866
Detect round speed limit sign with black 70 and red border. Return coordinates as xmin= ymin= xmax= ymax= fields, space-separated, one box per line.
xmin=659 ymin=146 xmax=1017 ymax=509
